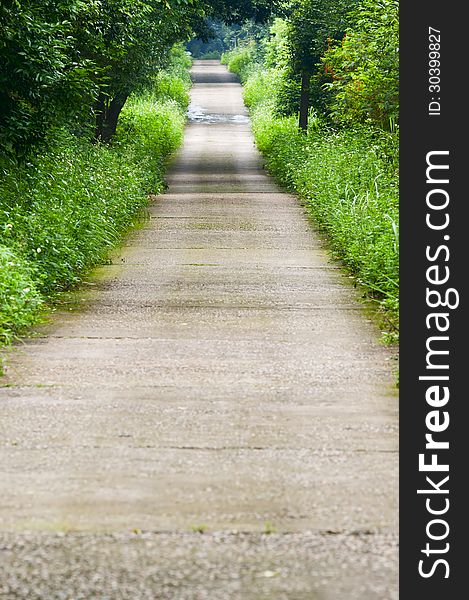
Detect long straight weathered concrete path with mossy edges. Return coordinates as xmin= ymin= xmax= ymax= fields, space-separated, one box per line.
xmin=0 ymin=61 xmax=398 ymax=600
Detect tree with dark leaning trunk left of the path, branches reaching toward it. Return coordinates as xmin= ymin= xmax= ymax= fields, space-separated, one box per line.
xmin=83 ymin=0 xmax=202 ymax=142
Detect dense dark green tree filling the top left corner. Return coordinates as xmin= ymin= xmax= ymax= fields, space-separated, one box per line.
xmin=0 ymin=0 xmax=96 ymax=154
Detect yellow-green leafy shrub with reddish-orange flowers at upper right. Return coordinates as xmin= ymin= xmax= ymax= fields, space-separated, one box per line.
xmin=323 ymin=0 xmax=399 ymax=129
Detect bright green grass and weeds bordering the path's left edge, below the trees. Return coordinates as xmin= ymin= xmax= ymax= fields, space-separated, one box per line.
xmin=0 ymin=50 xmax=189 ymax=344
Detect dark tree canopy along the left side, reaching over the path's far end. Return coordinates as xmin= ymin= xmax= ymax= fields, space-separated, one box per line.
xmin=0 ymin=0 xmax=276 ymax=154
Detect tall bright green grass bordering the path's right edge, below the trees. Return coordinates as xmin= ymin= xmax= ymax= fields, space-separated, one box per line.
xmin=253 ymin=104 xmax=399 ymax=331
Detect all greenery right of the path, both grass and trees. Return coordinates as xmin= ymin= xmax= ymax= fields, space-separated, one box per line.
xmin=222 ymin=0 xmax=399 ymax=342
